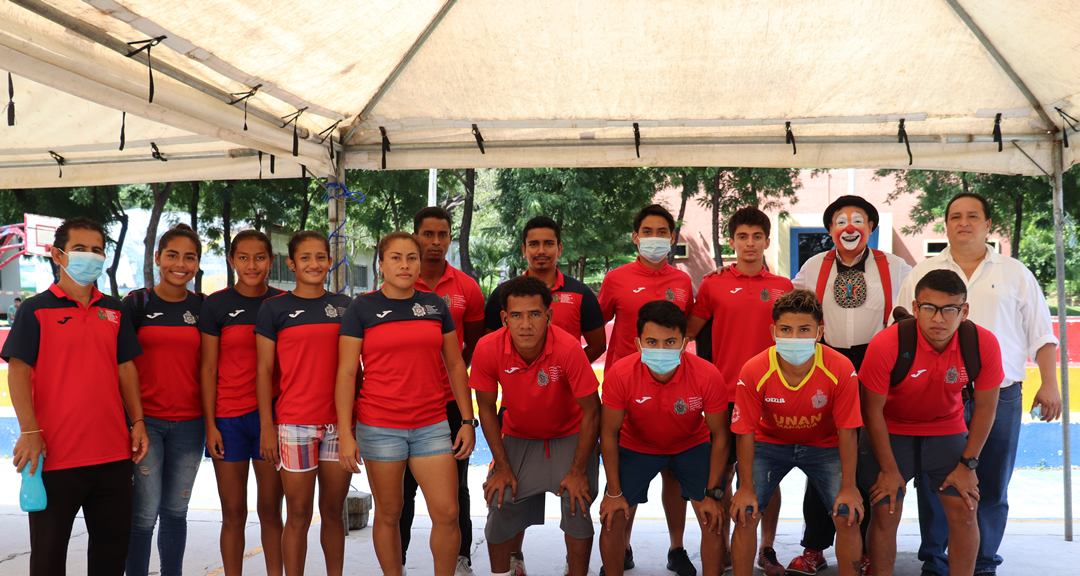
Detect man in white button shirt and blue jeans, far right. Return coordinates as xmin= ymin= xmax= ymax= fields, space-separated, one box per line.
xmin=896 ymin=192 xmax=1062 ymax=576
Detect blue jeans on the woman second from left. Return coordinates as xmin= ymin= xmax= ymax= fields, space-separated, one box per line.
xmin=125 ymin=416 xmax=206 ymax=576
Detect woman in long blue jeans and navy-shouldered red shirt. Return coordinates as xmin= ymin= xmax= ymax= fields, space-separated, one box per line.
xmin=123 ymin=224 xmax=206 ymax=576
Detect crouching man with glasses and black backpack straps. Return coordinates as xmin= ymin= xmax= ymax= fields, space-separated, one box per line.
xmin=859 ymin=269 xmax=1004 ymax=576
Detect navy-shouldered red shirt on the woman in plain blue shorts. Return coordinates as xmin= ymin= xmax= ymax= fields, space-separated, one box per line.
xmin=199 ymin=287 xmax=284 ymax=418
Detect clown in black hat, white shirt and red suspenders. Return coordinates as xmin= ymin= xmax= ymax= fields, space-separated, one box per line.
xmin=787 ymin=196 xmax=912 ymax=576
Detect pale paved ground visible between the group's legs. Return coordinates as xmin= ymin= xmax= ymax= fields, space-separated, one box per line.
xmin=0 ymin=458 xmax=1080 ymax=576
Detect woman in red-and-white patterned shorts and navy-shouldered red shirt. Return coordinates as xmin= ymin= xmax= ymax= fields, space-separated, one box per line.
xmin=255 ymin=230 xmax=352 ymax=576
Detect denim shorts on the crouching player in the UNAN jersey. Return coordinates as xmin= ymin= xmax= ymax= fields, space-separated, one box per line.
xmin=754 ymin=442 xmax=848 ymax=515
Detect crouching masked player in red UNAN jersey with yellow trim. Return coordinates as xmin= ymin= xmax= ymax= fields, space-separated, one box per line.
xmin=731 ymin=290 xmax=863 ymax=576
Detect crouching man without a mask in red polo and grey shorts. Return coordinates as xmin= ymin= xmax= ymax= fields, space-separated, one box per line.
xmin=469 ymin=276 xmax=609 ymax=576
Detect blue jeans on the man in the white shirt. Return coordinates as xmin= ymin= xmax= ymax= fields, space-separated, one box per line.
xmin=918 ymin=384 xmax=1024 ymax=576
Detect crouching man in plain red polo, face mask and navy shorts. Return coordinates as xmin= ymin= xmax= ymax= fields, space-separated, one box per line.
xmin=600 ymin=300 xmax=729 ymax=576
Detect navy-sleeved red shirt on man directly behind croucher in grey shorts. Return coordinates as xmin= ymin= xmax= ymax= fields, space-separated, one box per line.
xmin=484 ymin=270 xmax=605 ymax=346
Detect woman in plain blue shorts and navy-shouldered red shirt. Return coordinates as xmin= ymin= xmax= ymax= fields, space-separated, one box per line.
xmin=199 ymin=230 xmax=284 ymax=576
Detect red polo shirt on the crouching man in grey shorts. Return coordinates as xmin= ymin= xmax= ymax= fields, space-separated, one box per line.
xmin=469 ymin=326 xmax=599 ymax=440
